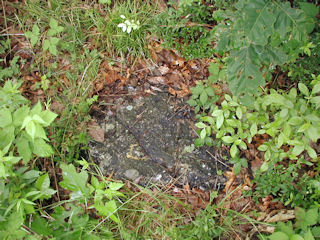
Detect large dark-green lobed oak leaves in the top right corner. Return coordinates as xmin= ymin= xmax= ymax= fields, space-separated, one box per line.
xmin=216 ymin=0 xmax=318 ymax=104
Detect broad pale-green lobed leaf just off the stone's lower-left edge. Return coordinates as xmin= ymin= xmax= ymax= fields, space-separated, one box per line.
xmin=59 ymin=164 xmax=90 ymax=198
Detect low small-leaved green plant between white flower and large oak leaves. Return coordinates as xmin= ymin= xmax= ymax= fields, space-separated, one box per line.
xmin=154 ymin=1 xmax=214 ymax=59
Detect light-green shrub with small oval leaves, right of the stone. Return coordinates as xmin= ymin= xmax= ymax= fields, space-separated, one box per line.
xmin=196 ymin=75 xmax=320 ymax=171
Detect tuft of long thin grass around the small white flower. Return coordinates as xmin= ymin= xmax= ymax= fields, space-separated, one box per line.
xmin=96 ymin=0 xmax=156 ymax=60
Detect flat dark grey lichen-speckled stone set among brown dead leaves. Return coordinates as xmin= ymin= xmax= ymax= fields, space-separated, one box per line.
xmin=89 ymin=93 xmax=225 ymax=190
